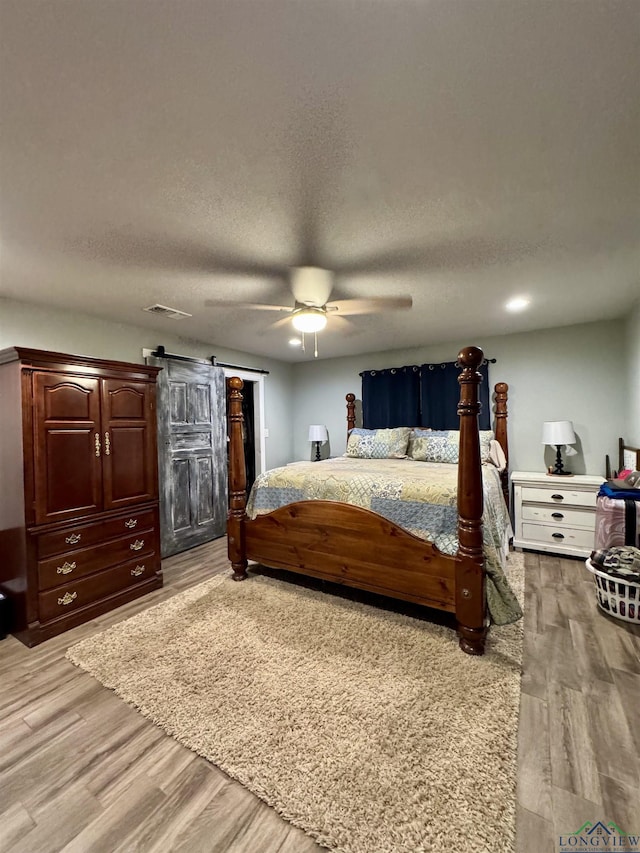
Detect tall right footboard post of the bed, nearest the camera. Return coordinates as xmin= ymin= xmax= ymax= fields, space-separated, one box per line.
xmin=456 ymin=347 xmax=487 ymax=655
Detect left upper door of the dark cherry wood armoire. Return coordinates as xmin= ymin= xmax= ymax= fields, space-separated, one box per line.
xmin=33 ymin=373 xmax=102 ymax=524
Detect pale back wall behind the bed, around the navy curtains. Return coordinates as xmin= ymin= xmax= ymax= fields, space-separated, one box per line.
xmin=293 ymin=321 xmax=628 ymax=475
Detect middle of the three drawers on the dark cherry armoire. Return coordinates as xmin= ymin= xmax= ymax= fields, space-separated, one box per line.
xmin=38 ymin=530 xmax=156 ymax=589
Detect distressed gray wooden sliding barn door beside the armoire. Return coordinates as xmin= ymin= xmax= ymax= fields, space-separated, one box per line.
xmin=147 ymin=358 xmax=227 ymax=557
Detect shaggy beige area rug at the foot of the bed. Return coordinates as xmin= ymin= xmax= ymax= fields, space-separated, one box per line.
xmin=68 ymin=554 xmax=523 ymax=853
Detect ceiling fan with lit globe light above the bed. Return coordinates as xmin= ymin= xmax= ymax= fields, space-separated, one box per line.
xmin=205 ymin=267 xmax=413 ymax=355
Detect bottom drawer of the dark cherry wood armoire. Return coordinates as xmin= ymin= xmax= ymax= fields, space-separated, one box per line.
xmin=38 ymin=554 xmax=159 ymax=622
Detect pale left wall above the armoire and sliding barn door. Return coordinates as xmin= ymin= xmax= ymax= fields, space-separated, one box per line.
xmin=0 ymin=299 xmax=293 ymax=468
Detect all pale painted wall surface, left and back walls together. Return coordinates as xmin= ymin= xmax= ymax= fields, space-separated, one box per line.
xmin=0 ymin=299 xmax=640 ymax=474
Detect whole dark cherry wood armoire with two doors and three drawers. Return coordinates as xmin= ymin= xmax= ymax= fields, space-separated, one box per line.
xmin=0 ymin=347 xmax=162 ymax=646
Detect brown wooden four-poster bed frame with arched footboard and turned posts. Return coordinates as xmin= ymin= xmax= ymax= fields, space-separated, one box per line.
xmin=227 ymin=347 xmax=508 ymax=655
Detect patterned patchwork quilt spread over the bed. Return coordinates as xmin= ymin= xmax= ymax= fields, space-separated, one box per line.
xmin=247 ymin=456 xmax=522 ymax=625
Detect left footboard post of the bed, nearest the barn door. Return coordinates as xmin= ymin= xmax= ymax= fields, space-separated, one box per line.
xmin=227 ymin=376 xmax=247 ymax=581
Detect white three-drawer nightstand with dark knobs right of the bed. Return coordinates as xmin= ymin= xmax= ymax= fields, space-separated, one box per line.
xmin=511 ymin=471 xmax=604 ymax=557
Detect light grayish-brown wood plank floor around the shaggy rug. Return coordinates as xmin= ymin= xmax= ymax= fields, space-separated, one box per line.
xmin=0 ymin=540 xmax=640 ymax=853
